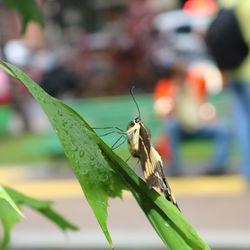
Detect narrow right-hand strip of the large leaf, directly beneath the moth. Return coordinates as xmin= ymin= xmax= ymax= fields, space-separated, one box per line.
xmin=100 ymin=141 xmax=210 ymax=250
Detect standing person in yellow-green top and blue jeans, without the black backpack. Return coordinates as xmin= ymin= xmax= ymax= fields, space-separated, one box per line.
xmin=211 ymin=0 xmax=250 ymax=183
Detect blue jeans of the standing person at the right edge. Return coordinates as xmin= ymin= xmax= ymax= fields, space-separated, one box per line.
xmin=229 ymin=81 xmax=250 ymax=182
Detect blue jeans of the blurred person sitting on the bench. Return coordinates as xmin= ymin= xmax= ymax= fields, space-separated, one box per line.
xmin=165 ymin=118 xmax=231 ymax=174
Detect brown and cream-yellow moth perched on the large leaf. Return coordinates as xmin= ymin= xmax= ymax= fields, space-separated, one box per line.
xmin=126 ymin=88 xmax=179 ymax=209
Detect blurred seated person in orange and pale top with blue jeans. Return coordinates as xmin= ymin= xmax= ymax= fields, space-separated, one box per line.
xmin=155 ymin=61 xmax=230 ymax=175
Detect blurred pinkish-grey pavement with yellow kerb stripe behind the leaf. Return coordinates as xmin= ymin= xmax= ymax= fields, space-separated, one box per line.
xmin=0 ymin=167 xmax=250 ymax=250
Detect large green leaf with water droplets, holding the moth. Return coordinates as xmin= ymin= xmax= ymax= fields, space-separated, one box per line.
xmin=0 ymin=62 xmax=210 ymax=250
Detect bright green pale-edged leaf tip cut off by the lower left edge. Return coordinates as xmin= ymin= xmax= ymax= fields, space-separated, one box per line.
xmin=0 ymin=186 xmax=22 ymax=249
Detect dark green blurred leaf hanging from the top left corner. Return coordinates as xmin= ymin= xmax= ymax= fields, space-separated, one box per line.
xmin=4 ymin=0 xmax=43 ymax=33
